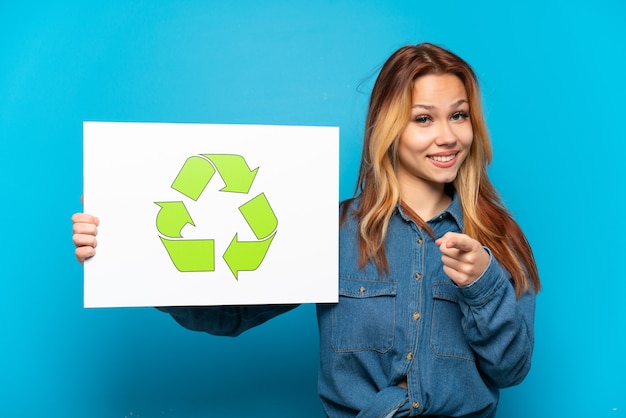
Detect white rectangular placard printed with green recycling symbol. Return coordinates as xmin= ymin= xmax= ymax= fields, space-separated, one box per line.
xmin=83 ymin=122 xmax=339 ymax=307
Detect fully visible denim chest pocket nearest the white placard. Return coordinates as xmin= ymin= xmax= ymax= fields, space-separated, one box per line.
xmin=331 ymin=278 xmax=397 ymax=353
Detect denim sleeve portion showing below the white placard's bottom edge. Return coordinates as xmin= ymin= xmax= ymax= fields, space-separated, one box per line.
xmin=157 ymin=305 xmax=298 ymax=337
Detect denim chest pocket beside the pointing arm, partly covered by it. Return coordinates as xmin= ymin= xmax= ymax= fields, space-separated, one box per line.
xmin=430 ymin=282 xmax=474 ymax=361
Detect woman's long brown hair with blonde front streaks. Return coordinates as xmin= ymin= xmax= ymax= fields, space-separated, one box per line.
xmin=342 ymin=43 xmax=540 ymax=297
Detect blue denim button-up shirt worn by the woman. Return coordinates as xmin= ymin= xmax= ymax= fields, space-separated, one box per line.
xmin=161 ymin=191 xmax=535 ymax=418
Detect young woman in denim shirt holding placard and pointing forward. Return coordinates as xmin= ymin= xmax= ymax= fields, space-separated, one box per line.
xmin=73 ymin=43 xmax=540 ymax=418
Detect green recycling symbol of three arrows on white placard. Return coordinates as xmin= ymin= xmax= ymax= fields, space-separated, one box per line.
xmin=154 ymin=154 xmax=278 ymax=279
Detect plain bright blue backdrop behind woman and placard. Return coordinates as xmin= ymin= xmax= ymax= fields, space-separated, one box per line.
xmin=0 ymin=0 xmax=626 ymax=418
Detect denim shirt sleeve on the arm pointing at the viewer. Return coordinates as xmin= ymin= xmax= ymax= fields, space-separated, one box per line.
xmin=459 ymin=250 xmax=535 ymax=388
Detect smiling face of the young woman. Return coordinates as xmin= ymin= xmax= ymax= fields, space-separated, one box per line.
xmin=396 ymin=74 xmax=474 ymax=193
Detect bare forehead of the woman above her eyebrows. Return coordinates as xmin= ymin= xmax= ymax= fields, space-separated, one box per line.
xmin=412 ymin=74 xmax=467 ymax=103
